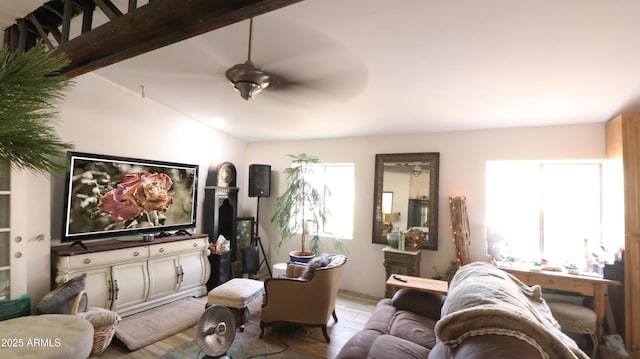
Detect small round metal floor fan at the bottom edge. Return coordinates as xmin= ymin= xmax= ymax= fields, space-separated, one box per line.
xmin=196 ymin=305 xmax=236 ymax=359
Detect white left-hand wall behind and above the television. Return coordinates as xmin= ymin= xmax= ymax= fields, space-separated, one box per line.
xmin=21 ymin=74 xmax=245 ymax=308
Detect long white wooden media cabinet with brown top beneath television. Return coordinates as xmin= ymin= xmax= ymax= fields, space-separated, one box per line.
xmin=52 ymin=235 xmax=211 ymax=316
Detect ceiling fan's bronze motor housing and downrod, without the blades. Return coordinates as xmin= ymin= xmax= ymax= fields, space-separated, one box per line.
xmin=225 ymin=18 xmax=275 ymax=100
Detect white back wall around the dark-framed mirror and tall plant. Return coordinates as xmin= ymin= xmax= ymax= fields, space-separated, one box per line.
xmin=244 ymin=123 xmax=605 ymax=297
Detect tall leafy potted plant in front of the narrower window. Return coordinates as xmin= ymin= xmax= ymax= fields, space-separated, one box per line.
xmin=271 ymin=153 xmax=343 ymax=262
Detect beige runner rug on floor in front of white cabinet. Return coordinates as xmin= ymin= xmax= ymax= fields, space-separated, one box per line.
xmin=115 ymin=298 xmax=204 ymax=350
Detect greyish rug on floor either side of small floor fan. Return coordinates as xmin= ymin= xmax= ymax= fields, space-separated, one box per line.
xmin=159 ymin=332 xmax=309 ymax=359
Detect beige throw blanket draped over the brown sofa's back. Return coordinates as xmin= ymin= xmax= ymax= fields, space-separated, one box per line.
xmin=435 ymin=262 xmax=588 ymax=359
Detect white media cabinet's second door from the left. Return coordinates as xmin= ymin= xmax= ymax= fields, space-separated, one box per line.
xmin=111 ymin=261 xmax=149 ymax=312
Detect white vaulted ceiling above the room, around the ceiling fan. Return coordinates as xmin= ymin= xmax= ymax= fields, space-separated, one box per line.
xmin=0 ymin=0 xmax=640 ymax=142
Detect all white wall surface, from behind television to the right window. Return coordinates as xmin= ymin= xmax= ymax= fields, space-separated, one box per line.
xmin=17 ymin=74 xmax=604 ymax=301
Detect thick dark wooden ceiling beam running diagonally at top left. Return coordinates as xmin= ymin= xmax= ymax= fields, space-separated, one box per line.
xmin=54 ymin=0 xmax=302 ymax=77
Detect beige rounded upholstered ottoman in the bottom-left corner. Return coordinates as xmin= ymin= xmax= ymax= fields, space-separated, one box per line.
xmin=0 ymin=314 xmax=93 ymax=359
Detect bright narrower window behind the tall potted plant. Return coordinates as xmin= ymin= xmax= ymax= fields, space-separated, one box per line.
xmin=308 ymin=163 xmax=355 ymax=239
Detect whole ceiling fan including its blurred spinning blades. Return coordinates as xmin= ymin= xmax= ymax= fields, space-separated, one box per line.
xmin=125 ymin=18 xmax=367 ymax=106
